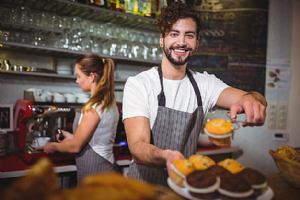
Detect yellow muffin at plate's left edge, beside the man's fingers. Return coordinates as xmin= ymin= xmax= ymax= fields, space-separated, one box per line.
xmin=169 ymin=159 xmax=194 ymax=187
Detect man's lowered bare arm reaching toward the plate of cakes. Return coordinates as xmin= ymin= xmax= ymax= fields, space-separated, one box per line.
xmin=124 ymin=117 xmax=183 ymax=167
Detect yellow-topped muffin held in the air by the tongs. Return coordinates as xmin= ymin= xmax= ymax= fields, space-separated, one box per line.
xmin=204 ymin=118 xmax=235 ymax=147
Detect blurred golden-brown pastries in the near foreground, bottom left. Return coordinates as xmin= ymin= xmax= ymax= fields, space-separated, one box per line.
xmin=1 ymin=158 xmax=182 ymax=200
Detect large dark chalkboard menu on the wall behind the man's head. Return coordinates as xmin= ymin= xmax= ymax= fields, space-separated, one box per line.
xmin=189 ymin=0 xmax=268 ymax=93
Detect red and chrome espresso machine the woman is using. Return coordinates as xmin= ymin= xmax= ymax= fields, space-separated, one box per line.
xmin=14 ymin=99 xmax=76 ymax=163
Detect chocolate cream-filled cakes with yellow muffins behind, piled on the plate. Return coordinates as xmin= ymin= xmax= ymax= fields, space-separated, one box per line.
xmin=168 ymin=155 xmax=273 ymax=200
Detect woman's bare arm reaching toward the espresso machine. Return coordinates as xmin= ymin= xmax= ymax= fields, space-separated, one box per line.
xmin=43 ymin=109 xmax=100 ymax=153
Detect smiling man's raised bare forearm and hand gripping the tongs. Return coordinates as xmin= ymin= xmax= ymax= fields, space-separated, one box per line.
xmin=217 ymin=87 xmax=267 ymax=125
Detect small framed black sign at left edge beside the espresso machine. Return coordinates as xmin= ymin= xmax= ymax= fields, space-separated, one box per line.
xmin=0 ymin=104 xmax=13 ymax=131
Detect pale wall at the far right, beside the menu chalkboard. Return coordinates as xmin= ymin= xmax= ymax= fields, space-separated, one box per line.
xmin=235 ymin=0 xmax=300 ymax=174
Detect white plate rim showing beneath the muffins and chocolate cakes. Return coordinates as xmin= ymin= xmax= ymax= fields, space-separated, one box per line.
xmin=167 ymin=177 xmax=274 ymax=200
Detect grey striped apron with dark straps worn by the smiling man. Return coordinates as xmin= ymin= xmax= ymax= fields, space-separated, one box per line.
xmin=128 ymin=67 xmax=204 ymax=185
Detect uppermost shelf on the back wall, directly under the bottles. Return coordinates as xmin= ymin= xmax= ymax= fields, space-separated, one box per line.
xmin=0 ymin=0 xmax=158 ymax=32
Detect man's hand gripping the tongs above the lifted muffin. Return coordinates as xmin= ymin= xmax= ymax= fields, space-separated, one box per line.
xmin=230 ymin=92 xmax=267 ymax=126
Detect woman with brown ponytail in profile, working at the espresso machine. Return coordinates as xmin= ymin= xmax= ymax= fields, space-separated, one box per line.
xmin=43 ymin=55 xmax=119 ymax=182
